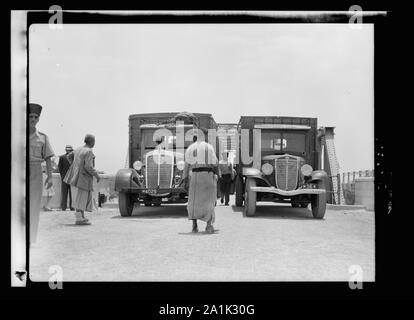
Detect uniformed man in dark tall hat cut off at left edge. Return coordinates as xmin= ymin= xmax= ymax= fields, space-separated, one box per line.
xmin=28 ymin=103 xmax=54 ymax=244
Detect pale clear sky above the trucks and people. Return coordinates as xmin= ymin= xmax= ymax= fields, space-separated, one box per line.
xmin=29 ymin=24 xmax=374 ymax=174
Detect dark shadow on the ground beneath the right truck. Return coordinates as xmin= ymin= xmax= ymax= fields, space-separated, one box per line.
xmin=232 ymin=204 xmax=318 ymax=221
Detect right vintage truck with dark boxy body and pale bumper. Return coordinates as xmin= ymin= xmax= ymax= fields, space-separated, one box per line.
xmin=235 ymin=116 xmax=329 ymax=219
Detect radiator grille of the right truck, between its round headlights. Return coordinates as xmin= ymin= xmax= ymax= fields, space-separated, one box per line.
xmin=275 ymin=157 xmax=300 ymax=191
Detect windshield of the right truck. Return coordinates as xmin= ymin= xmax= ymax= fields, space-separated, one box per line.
xmin=261 ymin=130 xmax=306 ymax=154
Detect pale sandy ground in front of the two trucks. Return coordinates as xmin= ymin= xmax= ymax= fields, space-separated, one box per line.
xmin=30 ymin=199 xmax=375 ymax=281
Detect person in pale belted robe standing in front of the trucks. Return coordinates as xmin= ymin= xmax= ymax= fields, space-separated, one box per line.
xmin=183 ymin=130 xmax=218 ymax=233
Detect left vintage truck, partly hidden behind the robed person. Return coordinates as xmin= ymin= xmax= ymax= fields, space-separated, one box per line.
xmin=115 ymin=112 xmax=217 ymax=216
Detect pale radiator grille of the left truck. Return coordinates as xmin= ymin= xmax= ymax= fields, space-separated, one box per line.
xmin=145 ymin=151 xmax=174 ymax=188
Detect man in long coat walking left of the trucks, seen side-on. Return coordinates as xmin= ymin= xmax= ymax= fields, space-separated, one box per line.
xmin=63 ymin=134 xmax=100 ymax=225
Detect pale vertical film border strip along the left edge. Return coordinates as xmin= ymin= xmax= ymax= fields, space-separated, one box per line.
xmin=10 ymin=11 xmax=28 ymax=287
